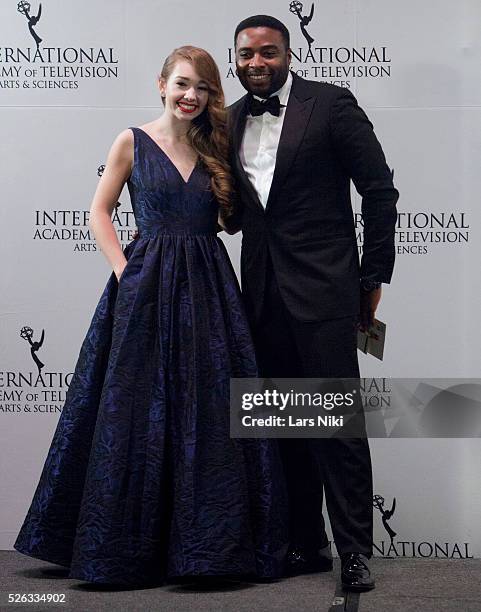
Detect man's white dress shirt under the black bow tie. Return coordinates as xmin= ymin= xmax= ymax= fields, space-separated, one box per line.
xmin=239 ymin=72 xmax=292 ymax=208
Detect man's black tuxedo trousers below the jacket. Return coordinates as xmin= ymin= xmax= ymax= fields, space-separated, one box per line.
xmin=251 ymin=261 xmax=373 ymax=557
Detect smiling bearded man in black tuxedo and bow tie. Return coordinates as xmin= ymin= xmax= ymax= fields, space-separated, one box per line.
xmin=229 ymin=15 xmax=398 ymax=590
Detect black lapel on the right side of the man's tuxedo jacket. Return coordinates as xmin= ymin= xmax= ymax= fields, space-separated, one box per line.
xmin=266 ymin=74 xmax=315 ymax=210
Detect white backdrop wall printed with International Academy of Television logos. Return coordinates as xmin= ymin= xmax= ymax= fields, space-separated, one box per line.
xmin=0 ymin=0 xmax=481 ymax=558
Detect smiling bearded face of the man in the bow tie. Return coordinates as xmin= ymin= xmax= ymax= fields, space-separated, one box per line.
xmin=235 ymin=28 xmax=291 ymax=98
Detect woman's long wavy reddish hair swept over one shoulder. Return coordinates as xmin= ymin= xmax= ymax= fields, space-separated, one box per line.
xmin=160 ymin=45 xmax=234 ymax=218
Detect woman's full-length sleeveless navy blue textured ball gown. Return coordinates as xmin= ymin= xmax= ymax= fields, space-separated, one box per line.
xmin=14 ymin=128 xmax=287 ymax=585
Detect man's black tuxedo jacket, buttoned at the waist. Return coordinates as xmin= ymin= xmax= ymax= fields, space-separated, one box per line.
xmin=228 ymin=74 xmax=399 ymax=321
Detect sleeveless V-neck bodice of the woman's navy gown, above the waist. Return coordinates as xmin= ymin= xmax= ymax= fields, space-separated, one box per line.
xmin=127 ymin=128 xmax=218 ymax=236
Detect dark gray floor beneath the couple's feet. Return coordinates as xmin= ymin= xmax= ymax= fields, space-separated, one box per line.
xmin=0 ymin=551 xmax=481 ymax=612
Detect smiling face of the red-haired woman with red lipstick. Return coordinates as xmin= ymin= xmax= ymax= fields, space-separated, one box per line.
xmin=159 ymin=60 xmax=209 ymax=121
